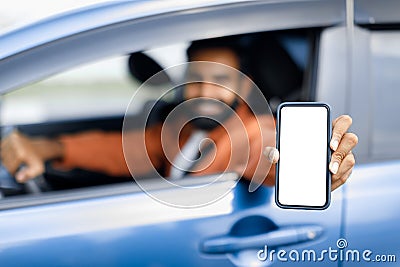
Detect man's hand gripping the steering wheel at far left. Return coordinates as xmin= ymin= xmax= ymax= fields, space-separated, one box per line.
xmin=1 ymin=131 xmax=63 ymax=183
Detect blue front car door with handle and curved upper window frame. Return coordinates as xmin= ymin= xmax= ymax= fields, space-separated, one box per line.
xmin=0 ymin=1 xmax=345 ymax=266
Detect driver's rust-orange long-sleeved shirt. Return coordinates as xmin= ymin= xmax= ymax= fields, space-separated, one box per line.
xmin=58 ymin=104 xmax=275 ymax=185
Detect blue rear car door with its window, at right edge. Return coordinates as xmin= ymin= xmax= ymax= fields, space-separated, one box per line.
xmin=345 ymin=1 xmax=400 ymax=266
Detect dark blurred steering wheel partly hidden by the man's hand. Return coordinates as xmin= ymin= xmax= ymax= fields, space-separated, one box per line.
xmin=0 ymin=126 xmax=48 ymax=198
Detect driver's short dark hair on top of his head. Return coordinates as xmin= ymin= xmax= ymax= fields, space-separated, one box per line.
xmin=186 ymin=36 xmax=248 ymax=74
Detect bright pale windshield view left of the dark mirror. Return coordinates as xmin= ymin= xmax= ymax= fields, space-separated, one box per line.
xmin=1 ymin=56 xmax=138 ymax=125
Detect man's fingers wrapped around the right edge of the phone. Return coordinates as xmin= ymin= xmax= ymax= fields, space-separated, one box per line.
xmin=329 ymin=115 xmax=358 ymax=191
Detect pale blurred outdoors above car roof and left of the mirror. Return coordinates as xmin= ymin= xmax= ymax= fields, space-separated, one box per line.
xmin=0 ymin=0 xmax=143 ymax=125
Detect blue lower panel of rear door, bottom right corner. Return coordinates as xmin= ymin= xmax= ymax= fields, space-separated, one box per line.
xmin=344 ymin=160 xmax=400 ymax=266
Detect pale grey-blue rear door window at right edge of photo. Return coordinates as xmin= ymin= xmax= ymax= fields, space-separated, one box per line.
xmin=370 ymin=31 xmax=400 ymax=159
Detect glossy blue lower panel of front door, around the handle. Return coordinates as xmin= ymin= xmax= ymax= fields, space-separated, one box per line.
xmin=0 ymin=179 xmax=341 ymax=266
